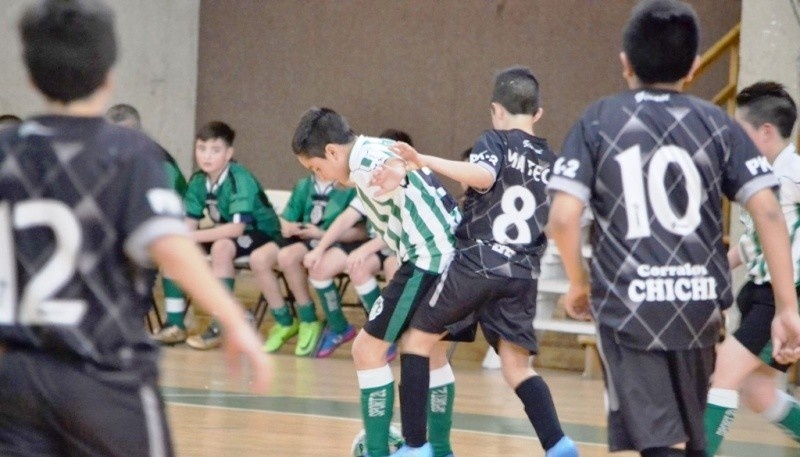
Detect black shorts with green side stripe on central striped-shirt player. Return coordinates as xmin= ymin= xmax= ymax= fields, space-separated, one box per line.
xmin=364 ymin=262 xmax=439 ymax=343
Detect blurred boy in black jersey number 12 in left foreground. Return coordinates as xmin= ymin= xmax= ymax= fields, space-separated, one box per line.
xmin=0 ymin=0 xmax=268 ymax=457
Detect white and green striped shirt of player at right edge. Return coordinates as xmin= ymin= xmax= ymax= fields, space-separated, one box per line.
xmin=739 ymin=144 xmax=800 ymax=285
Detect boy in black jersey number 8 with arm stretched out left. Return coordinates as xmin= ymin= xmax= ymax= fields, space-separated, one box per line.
xmin=388 ymin=67 xmax=578 ymax=457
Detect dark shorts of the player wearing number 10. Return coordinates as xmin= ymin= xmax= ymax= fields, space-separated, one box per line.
xmin=597 ymin=325 xmax=714 ymax=452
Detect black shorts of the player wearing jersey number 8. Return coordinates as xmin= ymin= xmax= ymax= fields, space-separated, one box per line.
xmin=411 ymin=257 xmax=539 ymax=354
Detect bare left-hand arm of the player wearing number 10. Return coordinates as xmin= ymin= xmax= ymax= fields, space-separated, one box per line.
xmin=547 ymin=192 xmax=592 ymax=320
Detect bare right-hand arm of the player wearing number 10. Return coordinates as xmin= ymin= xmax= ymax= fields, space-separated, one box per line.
xmin=745 ymin=189 xmax=800 ymax=363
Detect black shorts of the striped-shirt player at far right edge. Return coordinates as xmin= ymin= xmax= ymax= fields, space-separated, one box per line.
xmin=733 ymin=281 xmax=800 ymax=373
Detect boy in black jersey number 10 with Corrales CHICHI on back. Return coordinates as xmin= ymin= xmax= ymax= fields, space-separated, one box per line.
xmin=548 ymin=0 xmax=800 ymax=457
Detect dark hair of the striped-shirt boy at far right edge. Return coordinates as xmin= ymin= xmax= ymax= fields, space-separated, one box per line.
xmin=736 ymin=81 xmax=797 ymax=139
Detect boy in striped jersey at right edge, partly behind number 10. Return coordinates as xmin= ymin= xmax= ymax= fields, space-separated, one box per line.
xmin=705 ymin=81 xmax=800 ymax=456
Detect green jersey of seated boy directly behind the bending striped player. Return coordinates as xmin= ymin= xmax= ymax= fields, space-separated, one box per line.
xmin=282 ymin=175 xmax=356 ymax=230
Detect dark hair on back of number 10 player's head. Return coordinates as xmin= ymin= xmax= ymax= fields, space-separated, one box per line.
xmin=622 ymin=0 xmax=700 ymax=84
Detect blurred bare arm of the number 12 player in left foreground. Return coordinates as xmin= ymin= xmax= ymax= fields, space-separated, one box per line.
xmin=150 ymin=235 xmax=272 ymax=393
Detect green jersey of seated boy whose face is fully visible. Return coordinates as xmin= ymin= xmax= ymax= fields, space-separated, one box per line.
xmin=184 ymin=162 xmax=281 ymax=240
